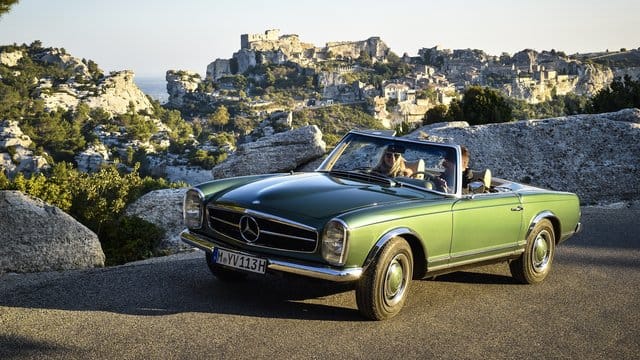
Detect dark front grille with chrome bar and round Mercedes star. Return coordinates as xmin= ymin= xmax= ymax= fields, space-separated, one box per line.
xmin=207 ymin=206 xmax=318 ymax=252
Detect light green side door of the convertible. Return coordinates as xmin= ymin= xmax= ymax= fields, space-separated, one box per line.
xmin=450 ymin=192 xmax=523 ymax=265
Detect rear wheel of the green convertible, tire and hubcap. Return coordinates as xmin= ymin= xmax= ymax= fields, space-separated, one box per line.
xmin=509 ymin=219 xmax=556 ymax=284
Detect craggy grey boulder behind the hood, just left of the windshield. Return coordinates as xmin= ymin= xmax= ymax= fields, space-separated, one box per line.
xmin=211 ymin=125 xmax=326 ymax=179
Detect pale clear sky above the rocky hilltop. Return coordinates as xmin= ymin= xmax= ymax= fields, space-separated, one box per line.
xmin=0 ymin=0 xmax=640 ymax=78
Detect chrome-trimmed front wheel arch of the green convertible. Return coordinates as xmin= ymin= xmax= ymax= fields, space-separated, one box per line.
xmin=362 ymin=227 xmax=427 ymax=279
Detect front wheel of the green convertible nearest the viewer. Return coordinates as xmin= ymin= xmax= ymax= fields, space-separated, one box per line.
xmin=356 ymin=237 xmax=413 ymax=320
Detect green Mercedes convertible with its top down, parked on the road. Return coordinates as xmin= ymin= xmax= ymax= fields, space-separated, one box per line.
xmin=181 ymin=131 xmax=580 ymax=320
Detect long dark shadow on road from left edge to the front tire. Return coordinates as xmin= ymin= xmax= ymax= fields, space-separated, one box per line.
xmin=0 ymin=259 xmax=363 ymax=321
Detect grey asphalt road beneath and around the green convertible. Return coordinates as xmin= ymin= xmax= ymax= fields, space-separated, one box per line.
xmin=0 ymin=208 xmax=640 ymax=359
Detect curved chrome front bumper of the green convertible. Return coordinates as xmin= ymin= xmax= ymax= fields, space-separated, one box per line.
xmin=180 ymin=230 xmax=362 ymax=282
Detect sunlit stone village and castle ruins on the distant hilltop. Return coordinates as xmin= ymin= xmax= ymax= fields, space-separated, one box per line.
xmin=167 ymin=30 xmax=637 ymax=128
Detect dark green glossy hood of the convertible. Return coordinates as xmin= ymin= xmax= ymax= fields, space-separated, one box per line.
xmin=215 ymin=173 xmax=425 ymax=220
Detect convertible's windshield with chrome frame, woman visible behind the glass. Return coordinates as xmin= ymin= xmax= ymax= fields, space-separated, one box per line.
xmin=318 ymin=133 xmax=460 ymax=194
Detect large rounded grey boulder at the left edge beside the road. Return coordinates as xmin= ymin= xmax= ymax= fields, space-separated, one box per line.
xmin=0 ymin=191 xmax=105 ymax=273
